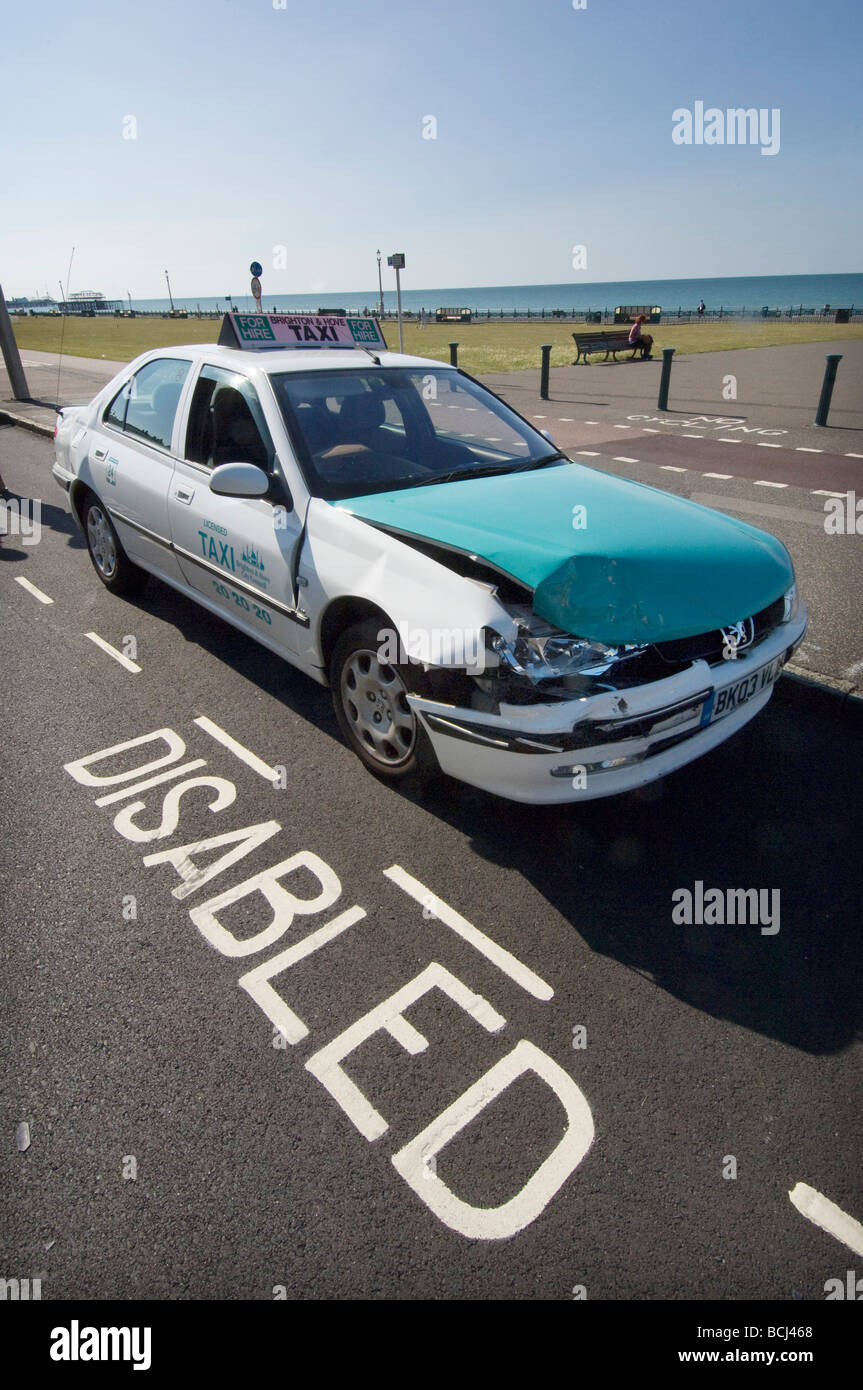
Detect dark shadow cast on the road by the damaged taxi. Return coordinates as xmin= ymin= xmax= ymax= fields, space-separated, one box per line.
xmin=124 ymin=569 xmax=863 ymax=1054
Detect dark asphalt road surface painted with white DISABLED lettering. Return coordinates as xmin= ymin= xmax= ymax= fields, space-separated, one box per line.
xmin=0 ymin=430 xmax=863 ymax=1301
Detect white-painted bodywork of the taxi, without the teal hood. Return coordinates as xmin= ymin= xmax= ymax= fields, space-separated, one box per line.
xmin=53 ymin=326 xmax=806 ymax=803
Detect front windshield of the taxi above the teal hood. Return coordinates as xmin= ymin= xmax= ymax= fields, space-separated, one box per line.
xmin=270 ymin=367 xmax=563 ymax=502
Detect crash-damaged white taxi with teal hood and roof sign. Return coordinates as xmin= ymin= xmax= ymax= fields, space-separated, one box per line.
xmin=54 ymin=314 xmax=806 ymax=802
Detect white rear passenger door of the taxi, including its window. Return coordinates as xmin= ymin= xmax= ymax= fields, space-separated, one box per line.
xmin=95 ymin=357 xmax=192 ymax=578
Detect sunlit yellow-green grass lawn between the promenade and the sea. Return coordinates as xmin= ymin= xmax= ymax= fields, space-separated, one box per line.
xmin=13 ymin=317 xmax=863 ymax=375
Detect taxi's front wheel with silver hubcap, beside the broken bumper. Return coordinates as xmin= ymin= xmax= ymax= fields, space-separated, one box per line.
xmin=329 ymin=619 xmax=441 ymax=783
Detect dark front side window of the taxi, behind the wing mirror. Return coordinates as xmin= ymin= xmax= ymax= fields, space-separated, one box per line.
xmin=185 ymin=367 xmax=275 ymax=473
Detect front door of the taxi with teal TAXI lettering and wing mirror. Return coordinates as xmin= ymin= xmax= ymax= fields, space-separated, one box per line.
xmin=168 ymin=364 xmax=307 ymax=652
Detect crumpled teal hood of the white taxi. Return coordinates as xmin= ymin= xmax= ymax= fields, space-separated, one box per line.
xmin=335 ymin=463 xmax=794 ymax=645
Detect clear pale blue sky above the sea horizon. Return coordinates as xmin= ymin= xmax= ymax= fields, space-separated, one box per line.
xmin=0 ymin=0 xmax=863 ymax=299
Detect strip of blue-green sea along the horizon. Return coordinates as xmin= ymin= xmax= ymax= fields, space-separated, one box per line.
xmin=15 ymin=271 xmax=863 ymax=317
